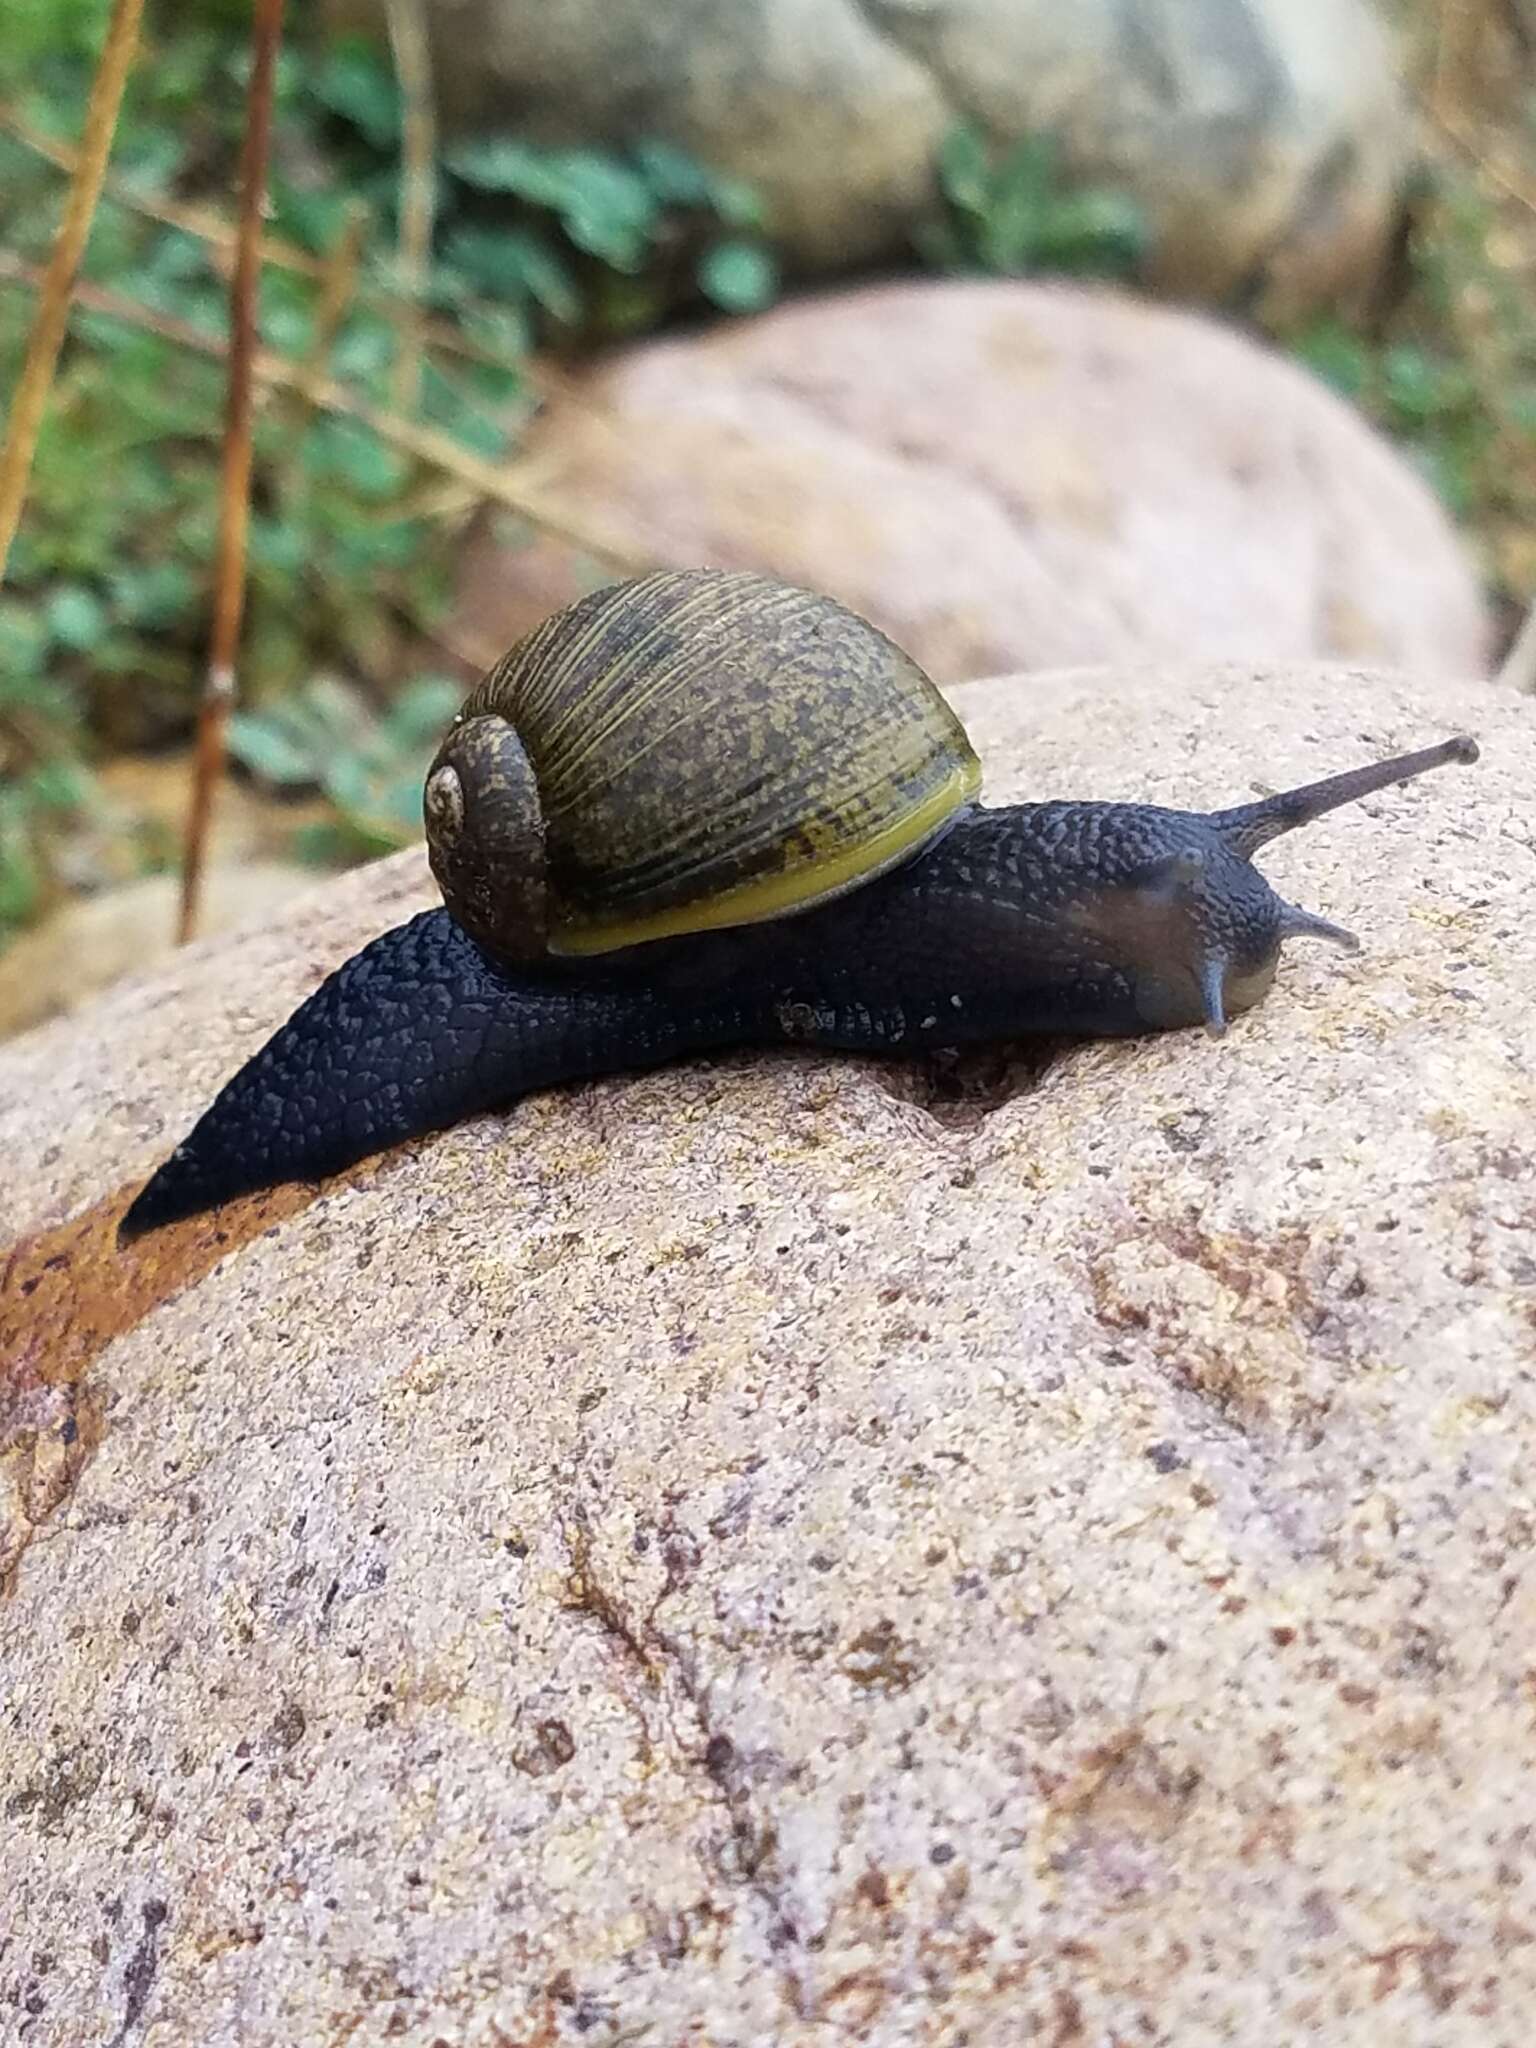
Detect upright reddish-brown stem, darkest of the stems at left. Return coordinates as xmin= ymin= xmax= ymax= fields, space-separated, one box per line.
xmin=176 ymin=0 xmax=283 ymax=944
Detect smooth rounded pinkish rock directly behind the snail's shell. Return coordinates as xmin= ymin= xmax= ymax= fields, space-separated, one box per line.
xmin=459 ymin=283 xmax=1487 ymax=680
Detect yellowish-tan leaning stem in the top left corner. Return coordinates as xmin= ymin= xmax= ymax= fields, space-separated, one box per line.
xmin=0 ymin=0 xmax=143 ymax=578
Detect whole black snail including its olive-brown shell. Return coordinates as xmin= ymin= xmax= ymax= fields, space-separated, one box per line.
xmin=123 ymin=571 xmax=1477 ymax=1237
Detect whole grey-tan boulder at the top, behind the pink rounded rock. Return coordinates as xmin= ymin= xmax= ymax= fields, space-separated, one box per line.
xmin=326 ymin=0 xmax=1409 ymax=313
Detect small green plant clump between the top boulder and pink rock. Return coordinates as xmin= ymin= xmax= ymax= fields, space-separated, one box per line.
xmin=920 ymin=121 xmax=1147 ymax=279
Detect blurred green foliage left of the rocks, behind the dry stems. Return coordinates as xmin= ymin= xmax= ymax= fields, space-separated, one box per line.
xmin=0 ymin=0 xmax=776 ymax=942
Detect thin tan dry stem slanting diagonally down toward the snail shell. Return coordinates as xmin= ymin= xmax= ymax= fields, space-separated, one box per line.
xmin=0 ymin=250 xmax=657 ymax=571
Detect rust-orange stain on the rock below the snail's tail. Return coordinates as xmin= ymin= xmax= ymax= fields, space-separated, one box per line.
xmin=0 ymin=1182 xmax=313 ymax=1593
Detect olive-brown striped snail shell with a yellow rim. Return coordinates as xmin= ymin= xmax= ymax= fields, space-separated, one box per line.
xmin=424 ymin=569 xmax=981 ymax=961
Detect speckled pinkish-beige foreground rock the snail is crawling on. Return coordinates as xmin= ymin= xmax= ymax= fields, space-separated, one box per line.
xmin=0 ymin=666 xmax=1536 ymax=2048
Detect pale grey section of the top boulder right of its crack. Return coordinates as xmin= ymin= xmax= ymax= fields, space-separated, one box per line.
xmin=862 ymin=0 xmax=1411 ymax=319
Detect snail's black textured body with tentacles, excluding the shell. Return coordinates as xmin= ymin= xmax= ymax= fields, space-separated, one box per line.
xmin=121 ymin=739 xmax=1477 ymax=1239
